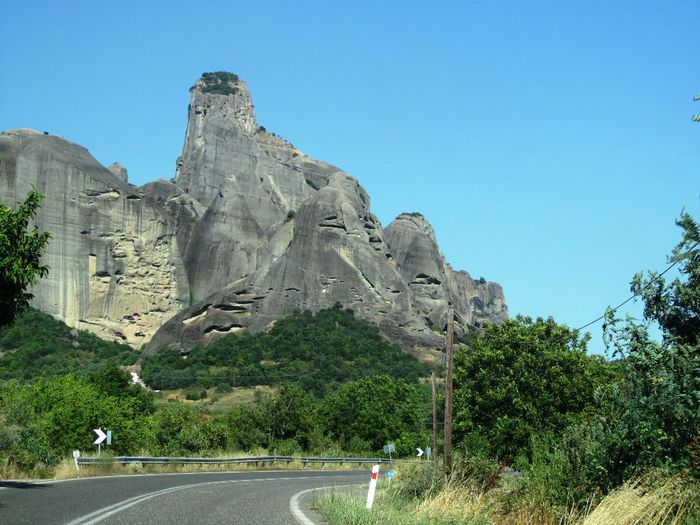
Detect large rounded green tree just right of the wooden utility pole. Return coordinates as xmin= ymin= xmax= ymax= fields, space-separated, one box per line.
xmin=454 ymin=316 xmax=613 ymax=459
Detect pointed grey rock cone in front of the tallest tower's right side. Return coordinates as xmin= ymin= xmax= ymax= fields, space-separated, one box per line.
xmin=150 ymin=172 xmax=442 ymax=353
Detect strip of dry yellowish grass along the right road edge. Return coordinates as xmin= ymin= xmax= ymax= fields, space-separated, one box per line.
xmin=319 ymin=466 xmax=700 ymax=525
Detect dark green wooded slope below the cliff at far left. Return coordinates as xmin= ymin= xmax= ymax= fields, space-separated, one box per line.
xmin=0 ymin=308 xmax=139 ymax=380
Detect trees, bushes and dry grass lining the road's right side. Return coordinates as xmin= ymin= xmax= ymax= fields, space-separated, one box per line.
xmin=317 ymin=214 xmax=700 ymax=525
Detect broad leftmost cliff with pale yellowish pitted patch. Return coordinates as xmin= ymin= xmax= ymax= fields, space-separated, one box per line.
xmin=0 ymin=130 xmax=191 ymax=345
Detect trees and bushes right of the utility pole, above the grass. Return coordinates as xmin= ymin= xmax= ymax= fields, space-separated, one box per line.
xmin=455 ymin=214 xmax=700 ymax=502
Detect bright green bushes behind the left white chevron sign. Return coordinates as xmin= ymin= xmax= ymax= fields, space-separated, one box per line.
xmin=0 ymin=367 xmax=154 ymax=470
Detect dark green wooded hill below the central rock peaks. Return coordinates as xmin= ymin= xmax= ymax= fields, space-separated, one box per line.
xmin=142 ymin=308 xmax=429 ymax=395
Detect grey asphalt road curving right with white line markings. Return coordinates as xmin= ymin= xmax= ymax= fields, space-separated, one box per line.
xmin=0 ymin=471 xmax=369 ymax=525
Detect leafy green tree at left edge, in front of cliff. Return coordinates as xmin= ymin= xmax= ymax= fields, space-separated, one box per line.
xmin=0 ymin=188 xmax=50 ymax=326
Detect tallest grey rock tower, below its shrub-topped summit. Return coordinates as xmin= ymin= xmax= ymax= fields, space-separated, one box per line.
xmin=176 ymin=76 xmax=338 ymax=300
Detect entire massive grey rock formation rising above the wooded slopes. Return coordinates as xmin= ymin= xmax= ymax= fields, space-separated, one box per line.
xmin=0 ymin=74 xmax=507 ymax=353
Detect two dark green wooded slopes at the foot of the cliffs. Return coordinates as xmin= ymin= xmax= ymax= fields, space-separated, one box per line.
xmin=0 ymin=308 xmax=429 ymax=396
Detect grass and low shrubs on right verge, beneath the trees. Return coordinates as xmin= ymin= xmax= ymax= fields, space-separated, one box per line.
xmin=313 ymin=457 xmax=700 ymax=525
